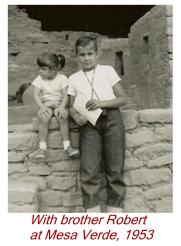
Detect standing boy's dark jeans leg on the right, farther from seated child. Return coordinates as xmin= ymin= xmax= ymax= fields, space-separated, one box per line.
xmin=104 ymin=109 xmax=125 ymax=208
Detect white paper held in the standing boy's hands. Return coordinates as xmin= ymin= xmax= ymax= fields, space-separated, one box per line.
xmin=73 ymin=94 xmax=103 ymax=126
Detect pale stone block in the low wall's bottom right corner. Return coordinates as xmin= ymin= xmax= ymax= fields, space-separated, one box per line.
xmin=149 ymin=197 xmax=173 ymax=213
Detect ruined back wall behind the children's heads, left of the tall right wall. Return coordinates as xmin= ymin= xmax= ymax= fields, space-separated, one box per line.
xmin=8 ymin=5 xmax=128 ymax=95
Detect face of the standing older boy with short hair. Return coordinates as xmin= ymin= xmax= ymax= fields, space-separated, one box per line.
xmin=77 ymin=42 xmax=97 ymax=71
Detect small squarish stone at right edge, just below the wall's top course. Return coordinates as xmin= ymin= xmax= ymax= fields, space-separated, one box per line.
xmin=155 ymin=126 xmax=173 ymax=141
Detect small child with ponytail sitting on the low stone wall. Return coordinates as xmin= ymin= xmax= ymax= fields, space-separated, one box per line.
xmin=32 ymin=53 xmax=79 ymax=158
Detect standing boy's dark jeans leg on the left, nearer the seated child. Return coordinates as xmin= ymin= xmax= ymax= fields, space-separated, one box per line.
xmin=80 ymin=123 xmax=102 ymax=209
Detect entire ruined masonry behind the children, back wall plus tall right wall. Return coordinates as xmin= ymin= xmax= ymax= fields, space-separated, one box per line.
xmin=8 ymin=5 xmax=173 ymax=110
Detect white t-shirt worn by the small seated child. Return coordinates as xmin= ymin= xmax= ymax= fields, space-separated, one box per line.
xmin=32 ymin=74 xmax=69 ymax=103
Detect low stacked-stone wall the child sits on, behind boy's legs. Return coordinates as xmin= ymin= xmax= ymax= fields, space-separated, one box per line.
xmin=8 ymin=109 xmax=172 ymax=212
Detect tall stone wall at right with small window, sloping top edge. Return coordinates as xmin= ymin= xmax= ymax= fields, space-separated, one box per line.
xmin=127 ymin=5 xmax=173 ymax=108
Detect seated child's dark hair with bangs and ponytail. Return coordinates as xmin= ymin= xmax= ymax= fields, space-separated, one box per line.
xmin=37 ymin=52 xmax=65 ymax=69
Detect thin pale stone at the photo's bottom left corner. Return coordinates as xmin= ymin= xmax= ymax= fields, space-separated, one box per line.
xmin=8 ymin=203 xmax=39 ymax=213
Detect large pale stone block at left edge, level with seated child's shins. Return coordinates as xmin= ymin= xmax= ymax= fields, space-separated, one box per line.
xmin=8 ymin=132 xmax=38 ymax=150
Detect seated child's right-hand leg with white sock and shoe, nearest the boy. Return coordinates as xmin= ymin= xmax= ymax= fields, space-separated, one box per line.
xmin=56 ymin=110 xmax=79 ymax=158
